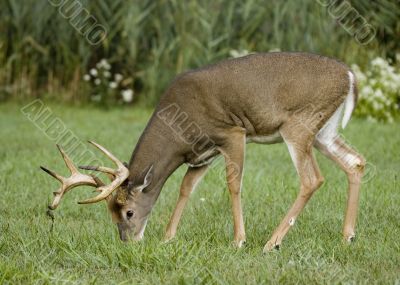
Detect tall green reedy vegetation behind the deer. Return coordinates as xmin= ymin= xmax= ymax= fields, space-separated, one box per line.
xmin=0 ymin=0 xmax=400 ymax=105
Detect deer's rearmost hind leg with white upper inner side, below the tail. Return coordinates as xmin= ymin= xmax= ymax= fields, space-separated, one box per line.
xmin=315 ymin=136 xmax=366 ymax=242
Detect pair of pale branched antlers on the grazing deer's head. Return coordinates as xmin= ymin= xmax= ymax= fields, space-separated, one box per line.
xmin=40 ymin=142 xmax=129 ymax=210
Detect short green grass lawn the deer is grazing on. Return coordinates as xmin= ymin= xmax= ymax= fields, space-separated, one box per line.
xmin=0 ymin=101 xmax=400 ymax=284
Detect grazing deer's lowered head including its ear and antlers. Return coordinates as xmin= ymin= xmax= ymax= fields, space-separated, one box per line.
xmin=40 ymin=141 xmax=153 ymax=241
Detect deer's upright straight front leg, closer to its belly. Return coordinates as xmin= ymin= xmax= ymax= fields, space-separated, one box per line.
xmin=220 ymin=129 xmax=246 ymax=248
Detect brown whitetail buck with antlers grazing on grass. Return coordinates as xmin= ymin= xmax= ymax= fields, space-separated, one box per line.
xmin=43 ymin=53 xmax=365 ymax=251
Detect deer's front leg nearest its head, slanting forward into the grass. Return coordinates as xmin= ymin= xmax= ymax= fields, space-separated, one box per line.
xmin=164 ymin=165 xmax=208 ymax=241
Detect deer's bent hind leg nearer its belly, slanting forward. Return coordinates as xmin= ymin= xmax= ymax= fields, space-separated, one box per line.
xmin=264 ymin=132 xmax=324 ymax=252
